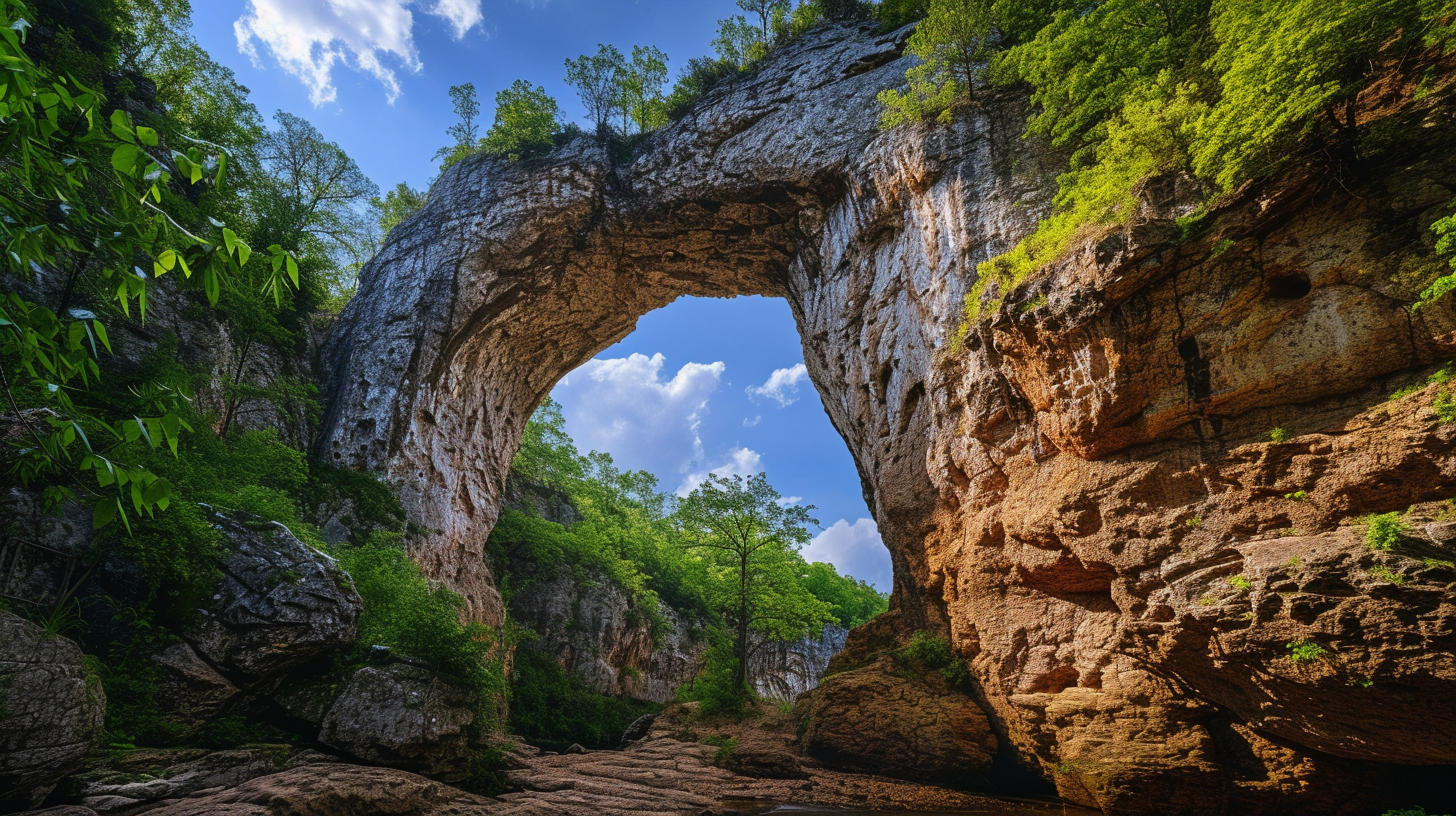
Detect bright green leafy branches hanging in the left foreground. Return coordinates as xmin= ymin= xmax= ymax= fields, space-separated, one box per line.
xmin=0 ymin=0 xmax=298 ymax=529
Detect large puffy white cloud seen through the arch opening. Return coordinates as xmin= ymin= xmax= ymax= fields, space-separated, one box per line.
xmin=555 ymin=354 xmax=724 ymax=479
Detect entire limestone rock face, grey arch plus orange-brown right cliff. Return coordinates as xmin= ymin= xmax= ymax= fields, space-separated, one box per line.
xmin=322 ymin=20 xmax=1456 ymax=813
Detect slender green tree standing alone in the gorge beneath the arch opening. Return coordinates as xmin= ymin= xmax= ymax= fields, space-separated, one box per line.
xmin=677 ymin=474 xmax=834 ymax=708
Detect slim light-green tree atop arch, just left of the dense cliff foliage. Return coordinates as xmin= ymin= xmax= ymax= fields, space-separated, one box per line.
xmin=878 ymin=0 xmax=993 ymax=127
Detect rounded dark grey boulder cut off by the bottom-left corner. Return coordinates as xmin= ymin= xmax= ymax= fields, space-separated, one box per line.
xmin=0 ymin=612 xmax=106 ymax=812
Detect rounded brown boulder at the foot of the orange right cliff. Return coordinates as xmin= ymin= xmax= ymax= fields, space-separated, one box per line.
xmin=798 ymin=657 xmax=997 ymax=785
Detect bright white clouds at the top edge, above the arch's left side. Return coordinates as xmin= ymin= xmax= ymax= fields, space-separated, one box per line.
xmin=233 ymin=0 xmax=483 ymax=105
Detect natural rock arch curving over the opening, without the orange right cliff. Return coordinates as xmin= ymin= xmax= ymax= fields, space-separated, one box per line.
xmin=322 ymin=28 xmax=1021 ymax=622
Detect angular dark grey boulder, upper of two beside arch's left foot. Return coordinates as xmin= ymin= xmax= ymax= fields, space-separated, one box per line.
xmin=186 ymin=516 xmax=361 ymax=682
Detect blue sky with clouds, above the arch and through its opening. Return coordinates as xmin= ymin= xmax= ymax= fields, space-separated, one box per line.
xmin=192 ymin=0 xmax=890 ymax=590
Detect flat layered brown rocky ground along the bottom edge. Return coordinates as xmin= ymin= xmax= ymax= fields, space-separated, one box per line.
xmin=25 ymin=704 xmax=1089 ymax=816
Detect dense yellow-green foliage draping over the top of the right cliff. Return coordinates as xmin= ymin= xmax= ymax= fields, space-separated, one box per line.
xmin=884 ymin=0 xmax=1456 ymax=323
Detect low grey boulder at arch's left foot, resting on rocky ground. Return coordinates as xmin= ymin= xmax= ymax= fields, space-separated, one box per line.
xmin=319 ymin=664 xmax=480 ymax=781
